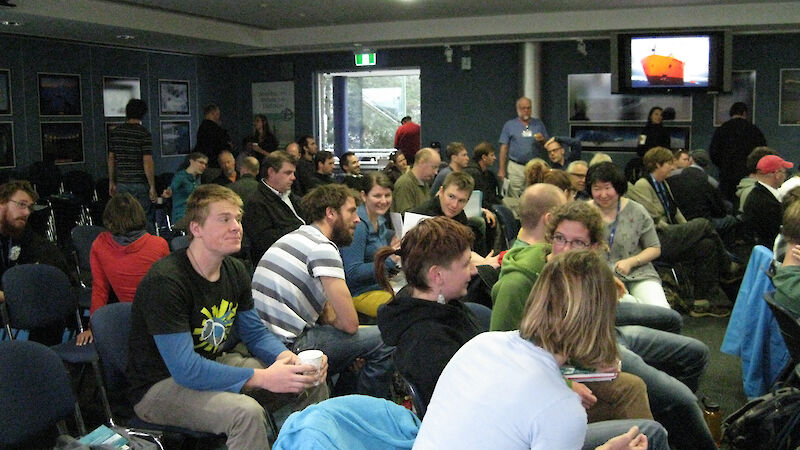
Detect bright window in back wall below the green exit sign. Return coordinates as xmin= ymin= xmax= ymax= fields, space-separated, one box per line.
xmin=317 ymin=69 xmax=420 ymax=154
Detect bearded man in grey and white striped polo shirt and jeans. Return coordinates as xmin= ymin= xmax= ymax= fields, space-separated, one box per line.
xmin=252 ymin=184 xmax=393 ymax=398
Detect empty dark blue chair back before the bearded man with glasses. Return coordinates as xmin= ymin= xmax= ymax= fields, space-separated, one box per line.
xmin=3 ymin=264 xmax=77 ymax=330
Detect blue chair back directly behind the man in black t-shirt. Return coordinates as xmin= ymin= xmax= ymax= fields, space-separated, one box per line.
xmin=90 ymin=303 xmax=131 ymax=392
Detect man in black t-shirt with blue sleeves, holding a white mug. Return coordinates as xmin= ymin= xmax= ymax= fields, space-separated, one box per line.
xmin=128 ymin=184 xmax=328 ymax=449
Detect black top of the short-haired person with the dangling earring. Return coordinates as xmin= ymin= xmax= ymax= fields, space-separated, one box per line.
xmin=378 ymin=296 xmax=481 ymax=405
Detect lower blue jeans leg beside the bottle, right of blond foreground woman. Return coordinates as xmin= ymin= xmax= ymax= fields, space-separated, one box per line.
xmin=617 ymin=326 xmax=716 ymax=450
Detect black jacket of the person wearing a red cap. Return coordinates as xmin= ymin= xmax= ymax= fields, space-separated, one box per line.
xmin=742 ymin=183 xmax=783 ymax=249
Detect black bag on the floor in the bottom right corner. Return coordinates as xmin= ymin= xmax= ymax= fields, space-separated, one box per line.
xmin=722 ymin=387 xmax=800 ymax=450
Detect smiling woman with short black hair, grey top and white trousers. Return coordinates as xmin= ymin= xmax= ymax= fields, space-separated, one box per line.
xmin=584 ymin=162 xmax=670 ymax=308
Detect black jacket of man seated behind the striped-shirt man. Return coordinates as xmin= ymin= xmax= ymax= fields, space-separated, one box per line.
xmin=242 ymin=183 xmax=303 ymax=267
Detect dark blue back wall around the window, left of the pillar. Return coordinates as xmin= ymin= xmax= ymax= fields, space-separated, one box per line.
xmin=231 ymin=45 xmax=519 ymax=155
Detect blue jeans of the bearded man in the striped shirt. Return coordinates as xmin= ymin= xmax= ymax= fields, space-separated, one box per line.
xmin=292 ymin=325 xmax=394 ymax=398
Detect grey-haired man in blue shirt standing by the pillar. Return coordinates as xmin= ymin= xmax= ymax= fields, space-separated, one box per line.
xmin=497 ymin=97 xmax=549 ymax=197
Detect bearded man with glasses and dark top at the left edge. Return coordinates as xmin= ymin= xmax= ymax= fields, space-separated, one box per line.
xmin=0 ymin=180 xmax=67 ymax=345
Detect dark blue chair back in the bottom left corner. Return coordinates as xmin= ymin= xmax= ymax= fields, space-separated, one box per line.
xmin=0 ymin=341 xmax=75 ymax=448
